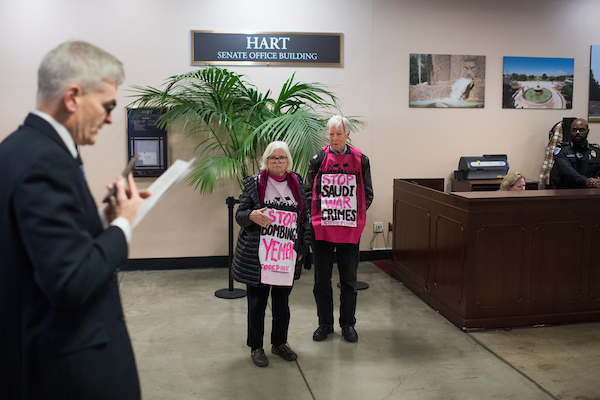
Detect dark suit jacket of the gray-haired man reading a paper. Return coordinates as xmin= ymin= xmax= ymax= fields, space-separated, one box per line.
xmin=0 ymin=114 xmax=140 ymax=400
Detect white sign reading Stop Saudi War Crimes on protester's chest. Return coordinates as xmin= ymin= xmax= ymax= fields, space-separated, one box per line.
xmin=320 ymin=174 xmax=358 ymax=228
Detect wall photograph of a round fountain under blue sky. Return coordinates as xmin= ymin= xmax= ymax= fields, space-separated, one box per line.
xmin=502 ymin=57 xmax=575 ymax=110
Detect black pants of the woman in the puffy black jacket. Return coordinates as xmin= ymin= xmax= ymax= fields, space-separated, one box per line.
xmin=246 ymin=284 xmax=292 ymax=350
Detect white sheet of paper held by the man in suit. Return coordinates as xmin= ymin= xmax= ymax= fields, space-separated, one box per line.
xmin=131 ymin=158 xmax=196 ymax=228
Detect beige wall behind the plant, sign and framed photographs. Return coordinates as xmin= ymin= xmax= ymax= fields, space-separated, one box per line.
xmin=0 ymin=0 xmax=600 ymax=258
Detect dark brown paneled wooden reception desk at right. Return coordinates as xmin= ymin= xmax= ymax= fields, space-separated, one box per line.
xmin=391 ymin=179 xmax=600 ymax=329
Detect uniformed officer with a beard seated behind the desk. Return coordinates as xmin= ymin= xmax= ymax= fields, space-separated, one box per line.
xmin=550 ymin=118 xmax=600 ymax=189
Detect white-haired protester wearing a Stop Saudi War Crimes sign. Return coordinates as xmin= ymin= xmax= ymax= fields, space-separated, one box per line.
xmin=305 ymin=115 xmax=373 ymax=342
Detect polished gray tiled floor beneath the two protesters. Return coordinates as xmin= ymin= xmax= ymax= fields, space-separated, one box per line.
xmin=121 ymin=262 xmax=600 ymax=400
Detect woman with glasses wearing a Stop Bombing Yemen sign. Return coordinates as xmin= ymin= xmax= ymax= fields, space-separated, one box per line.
xmin=232 ymin=142 xmax=310 ymax=367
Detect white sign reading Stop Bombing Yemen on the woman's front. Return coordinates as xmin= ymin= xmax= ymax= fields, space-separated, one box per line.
xmin=258 ymin=208 xmax=298 ymax=286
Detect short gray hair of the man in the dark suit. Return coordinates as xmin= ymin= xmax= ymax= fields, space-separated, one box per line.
xmin=37 ymin=41 xmax=125 ymax=102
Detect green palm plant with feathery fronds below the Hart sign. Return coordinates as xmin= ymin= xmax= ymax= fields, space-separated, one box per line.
xmin=129 ymin=66 xmax=362 ymax=194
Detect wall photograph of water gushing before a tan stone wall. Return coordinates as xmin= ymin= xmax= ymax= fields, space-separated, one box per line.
xmin=408 ymin=54 xmax=485 ymax=108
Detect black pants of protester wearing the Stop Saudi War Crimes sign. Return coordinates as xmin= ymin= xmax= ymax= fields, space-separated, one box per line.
xmin=312 ymin=240 xmax=359 ymax=328
